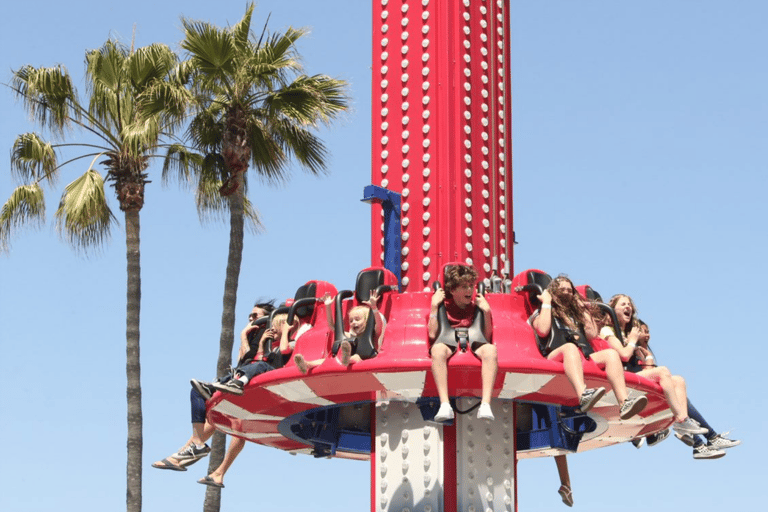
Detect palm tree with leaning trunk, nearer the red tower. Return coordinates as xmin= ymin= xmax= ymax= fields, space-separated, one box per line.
xmin=166 ymin=4 xmax=348 ymax=511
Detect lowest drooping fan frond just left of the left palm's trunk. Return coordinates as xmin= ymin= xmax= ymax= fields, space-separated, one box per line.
xmin=55 ymin=169 xmax=116 ymax=250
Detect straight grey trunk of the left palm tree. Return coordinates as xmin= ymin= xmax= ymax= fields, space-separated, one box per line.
xmin=125 ymin=209 xmax=143 ymax=512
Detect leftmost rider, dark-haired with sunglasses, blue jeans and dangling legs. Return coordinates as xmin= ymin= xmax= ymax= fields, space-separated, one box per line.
xmin=152 ymin=301 xmax=275 ymax=471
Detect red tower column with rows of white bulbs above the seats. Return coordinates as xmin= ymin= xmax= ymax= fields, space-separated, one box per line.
xmin=371 ymin=0 xmax=514 ymax=291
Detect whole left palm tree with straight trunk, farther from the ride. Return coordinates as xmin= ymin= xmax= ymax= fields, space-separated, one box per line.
xmin=0 ymin=40 xmax=187 ymax=512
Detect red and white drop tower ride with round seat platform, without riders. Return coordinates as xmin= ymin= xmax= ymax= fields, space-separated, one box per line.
xmin=208 ymin=0 xmax=672 ymax=512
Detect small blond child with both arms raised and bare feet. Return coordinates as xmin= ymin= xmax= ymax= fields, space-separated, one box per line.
xmin=293 ymin=290 xmax=387 ymax=373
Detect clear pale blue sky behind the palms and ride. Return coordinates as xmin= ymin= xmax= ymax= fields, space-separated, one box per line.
xmin=0 ymin=0 xmax=768 ymax=512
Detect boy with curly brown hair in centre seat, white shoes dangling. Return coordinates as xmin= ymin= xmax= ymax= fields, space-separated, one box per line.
xmin=427 ymin=265 xmax=498 ymax=422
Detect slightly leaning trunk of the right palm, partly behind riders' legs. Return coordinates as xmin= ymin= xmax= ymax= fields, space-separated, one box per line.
xmin=203 ymin=182 xmax=245 ymax=512
